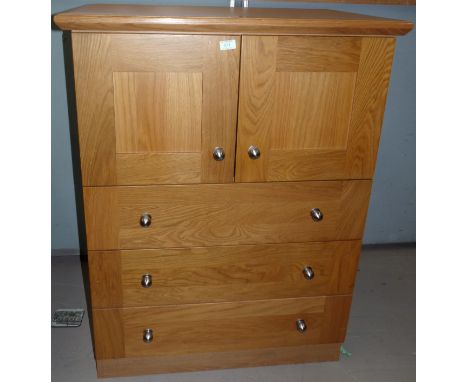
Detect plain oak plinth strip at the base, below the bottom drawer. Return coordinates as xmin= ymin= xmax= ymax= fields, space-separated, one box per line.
xmin=96 ymin=344 xmax=341 ymax=378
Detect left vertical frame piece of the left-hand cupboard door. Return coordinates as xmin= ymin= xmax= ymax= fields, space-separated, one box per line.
xmin=72 ymin=33 xmax=116 ymax=186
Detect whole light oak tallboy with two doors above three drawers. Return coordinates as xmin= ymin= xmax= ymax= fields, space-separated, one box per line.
xmin=54 ymin=5 xmax=412 ymax=377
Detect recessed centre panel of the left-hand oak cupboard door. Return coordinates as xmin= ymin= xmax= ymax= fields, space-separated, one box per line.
xmin=114 ymin=72 xmax=203 ymax=153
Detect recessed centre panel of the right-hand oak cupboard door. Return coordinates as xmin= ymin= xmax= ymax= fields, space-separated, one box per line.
xmin=268 ymin=72 xmax=356 ymax=151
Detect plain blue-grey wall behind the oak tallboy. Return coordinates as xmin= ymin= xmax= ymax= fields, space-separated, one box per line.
xmin=51 ymin=0 xmax=416 ymax=254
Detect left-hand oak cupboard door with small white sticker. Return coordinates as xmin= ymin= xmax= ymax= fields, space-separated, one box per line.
xmin=73 ymin=33 xmax=240 ymax=186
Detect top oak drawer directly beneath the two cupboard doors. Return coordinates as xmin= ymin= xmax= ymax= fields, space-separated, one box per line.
xmin=83 ymin=180 xmax=372 ymax=250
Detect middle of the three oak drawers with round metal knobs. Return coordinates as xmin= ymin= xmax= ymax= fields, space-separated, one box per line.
xmin=89 ymin=241 xmax=361 ymax=308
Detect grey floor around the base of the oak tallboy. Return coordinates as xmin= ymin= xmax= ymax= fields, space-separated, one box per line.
xmin=52 ymin=246 xmax=416 ymax=382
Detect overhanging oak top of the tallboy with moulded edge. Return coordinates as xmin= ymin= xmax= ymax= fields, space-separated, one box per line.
xmin=54 ymin=4 xmax=413 ymax=36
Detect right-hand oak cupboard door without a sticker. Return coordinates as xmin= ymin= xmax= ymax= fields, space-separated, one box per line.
xmin=236 ymin=36 xmax=394 ymax=182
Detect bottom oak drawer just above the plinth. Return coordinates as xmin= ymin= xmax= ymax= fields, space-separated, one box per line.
xmin=93 ymin=295 xmax=351 ymax=359
